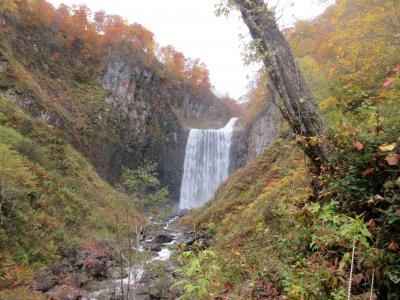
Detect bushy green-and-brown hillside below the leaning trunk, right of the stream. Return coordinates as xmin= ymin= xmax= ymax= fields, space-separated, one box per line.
xmin=179 ymin=128 xmax=400 ymax=299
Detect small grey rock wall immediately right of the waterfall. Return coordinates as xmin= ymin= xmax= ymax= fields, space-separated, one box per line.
xmin=229 ymin=103 xmax=282 ymax=173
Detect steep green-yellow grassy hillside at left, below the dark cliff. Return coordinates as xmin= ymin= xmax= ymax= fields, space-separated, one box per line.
xmin=0 ymin=89 xmax=141 ymax=297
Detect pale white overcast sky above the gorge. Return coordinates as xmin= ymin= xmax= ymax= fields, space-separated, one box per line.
xmin=49 ymin=0 xmax=330 ymax=99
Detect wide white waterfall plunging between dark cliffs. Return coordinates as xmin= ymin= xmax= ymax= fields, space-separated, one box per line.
xmin=179 ymin=118 xmax=237 ymax=209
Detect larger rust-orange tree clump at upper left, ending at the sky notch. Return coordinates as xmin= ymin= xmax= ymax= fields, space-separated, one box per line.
xmin=10 ymin=0 xmax=156 ymax=69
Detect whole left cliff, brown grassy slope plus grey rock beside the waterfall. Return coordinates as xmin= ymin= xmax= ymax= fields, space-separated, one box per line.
xmin=0 ymin=14 xmax=193 ymax=200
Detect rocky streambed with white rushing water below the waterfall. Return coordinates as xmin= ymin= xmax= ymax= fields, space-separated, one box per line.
xmin=35 ymin=216 xmax=211 ymax=300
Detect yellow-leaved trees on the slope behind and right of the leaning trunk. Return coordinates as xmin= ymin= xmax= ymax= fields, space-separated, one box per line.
xmin=288 ymin=0 xmax=400 ymax=95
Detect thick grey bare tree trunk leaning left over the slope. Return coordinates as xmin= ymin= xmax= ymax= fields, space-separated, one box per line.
xmin=232 ymin=0 xmax=332 ymax=167
